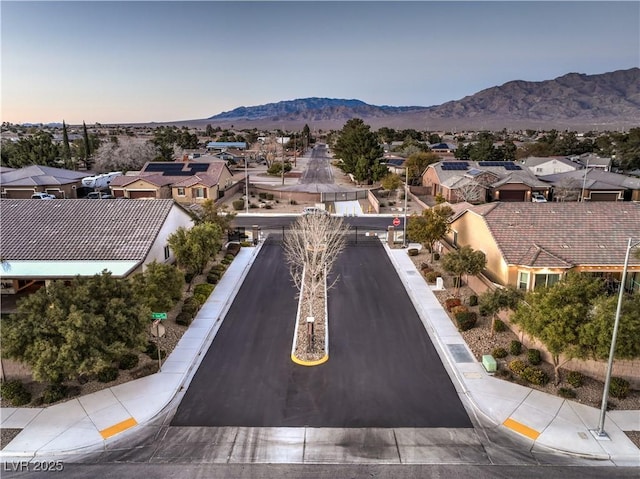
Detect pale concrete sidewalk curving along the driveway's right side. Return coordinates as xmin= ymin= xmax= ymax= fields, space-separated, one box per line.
xmin=385 ymin=245 xmax=640 ymax=466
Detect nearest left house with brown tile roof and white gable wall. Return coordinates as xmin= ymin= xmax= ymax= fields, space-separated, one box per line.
xmin=0 ymin=199 xmax=193 ymax=295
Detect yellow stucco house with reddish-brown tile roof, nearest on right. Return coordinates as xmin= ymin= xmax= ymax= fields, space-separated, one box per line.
xmin=446 ymin=202 xmax=640 ymax=291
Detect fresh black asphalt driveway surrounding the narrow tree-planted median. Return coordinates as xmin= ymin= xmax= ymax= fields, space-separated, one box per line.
xmin=171 ymin=240 xmax=472 ymax=428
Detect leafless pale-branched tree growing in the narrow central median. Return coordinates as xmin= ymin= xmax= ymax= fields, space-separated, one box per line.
xmin=284 ymin=214 xmax=349 ymax=352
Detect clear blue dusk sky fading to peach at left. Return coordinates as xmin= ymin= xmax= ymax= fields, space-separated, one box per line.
xmin=0 ymin=0 xmax=640 ymax=124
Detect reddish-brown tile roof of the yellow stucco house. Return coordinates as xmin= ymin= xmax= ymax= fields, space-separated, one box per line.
xmin=460 ymin=202 xmax=640 ymax=268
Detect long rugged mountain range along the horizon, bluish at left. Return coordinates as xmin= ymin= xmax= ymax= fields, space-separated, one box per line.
xmin=192 ymin=68 xmax=640 ymax=131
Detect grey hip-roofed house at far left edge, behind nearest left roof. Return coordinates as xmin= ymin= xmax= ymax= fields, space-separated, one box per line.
xmin=0 ymin=165 xmax=91 ymax=199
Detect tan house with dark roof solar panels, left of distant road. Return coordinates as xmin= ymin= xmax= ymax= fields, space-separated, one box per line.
xmin=110 ymin=161 xmax=233 ymax=205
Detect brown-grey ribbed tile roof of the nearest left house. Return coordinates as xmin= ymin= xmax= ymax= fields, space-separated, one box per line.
xmin=0 ymin=199 xmax=177 ymax=261
